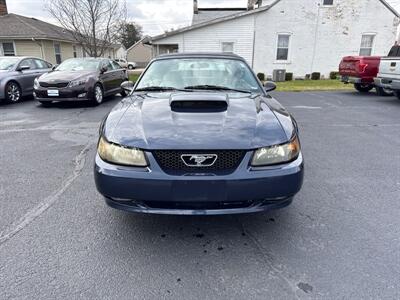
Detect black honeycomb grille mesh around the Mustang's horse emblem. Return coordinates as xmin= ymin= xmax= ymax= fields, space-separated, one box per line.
xmin=153 ymin=150 xmax=246 ymax=174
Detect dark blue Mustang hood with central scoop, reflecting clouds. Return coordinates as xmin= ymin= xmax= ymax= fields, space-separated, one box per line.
xmin=103 ymin=92 xmax=293 ymax=150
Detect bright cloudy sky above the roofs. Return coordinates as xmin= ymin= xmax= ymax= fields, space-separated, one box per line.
xmin=6 ymin=0 xmax=400 ymax=35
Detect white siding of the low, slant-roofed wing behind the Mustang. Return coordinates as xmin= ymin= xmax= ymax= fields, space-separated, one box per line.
xmin=154 ymin=16 xmax=254 ymax=64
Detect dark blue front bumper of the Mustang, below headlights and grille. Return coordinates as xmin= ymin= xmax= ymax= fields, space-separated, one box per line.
xmin=95 ymin=151 xmax=304 ymax=215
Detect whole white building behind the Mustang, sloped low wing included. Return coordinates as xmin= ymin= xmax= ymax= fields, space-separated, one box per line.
xmin=151 ymin=0 xmax=400 ymax=77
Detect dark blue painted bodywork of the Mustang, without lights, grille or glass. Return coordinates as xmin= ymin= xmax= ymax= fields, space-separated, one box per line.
xmin=95 ymin=54 xmax=304 ymax=214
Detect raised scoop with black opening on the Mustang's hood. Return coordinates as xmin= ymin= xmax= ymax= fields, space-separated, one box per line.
xmin=169 ymin=93 xmax=229 ymax=113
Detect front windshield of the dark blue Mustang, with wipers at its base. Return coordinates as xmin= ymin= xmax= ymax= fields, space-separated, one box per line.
xmin=136 ymin=58 xmax=260 ymax=92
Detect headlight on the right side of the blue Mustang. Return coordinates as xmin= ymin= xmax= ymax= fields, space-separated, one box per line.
xmin=251 ymin=136 xmax=300 ymax=167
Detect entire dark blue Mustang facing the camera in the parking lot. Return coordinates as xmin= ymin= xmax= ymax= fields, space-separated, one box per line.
xmin=95 ymin=54 xmax=304 ymax=214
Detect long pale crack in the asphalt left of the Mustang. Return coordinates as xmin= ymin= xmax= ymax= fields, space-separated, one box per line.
xmin=0 ymin=141 xmax=93 ymax=246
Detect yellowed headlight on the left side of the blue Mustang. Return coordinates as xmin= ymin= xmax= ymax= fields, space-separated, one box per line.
xmin=97 ymin=137 xmax=147 ymax=167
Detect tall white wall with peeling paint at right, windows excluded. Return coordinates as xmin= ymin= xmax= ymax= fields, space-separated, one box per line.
xmin=254 ymin=0 xmax=398 ymax=77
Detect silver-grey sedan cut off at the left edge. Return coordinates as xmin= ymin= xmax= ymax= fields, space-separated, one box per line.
xmin=0 ymin=56 xmax=52 ymax=103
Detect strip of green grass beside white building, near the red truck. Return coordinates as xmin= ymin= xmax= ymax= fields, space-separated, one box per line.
xmin=276 ymin=79 xmax=354 ymax=92
